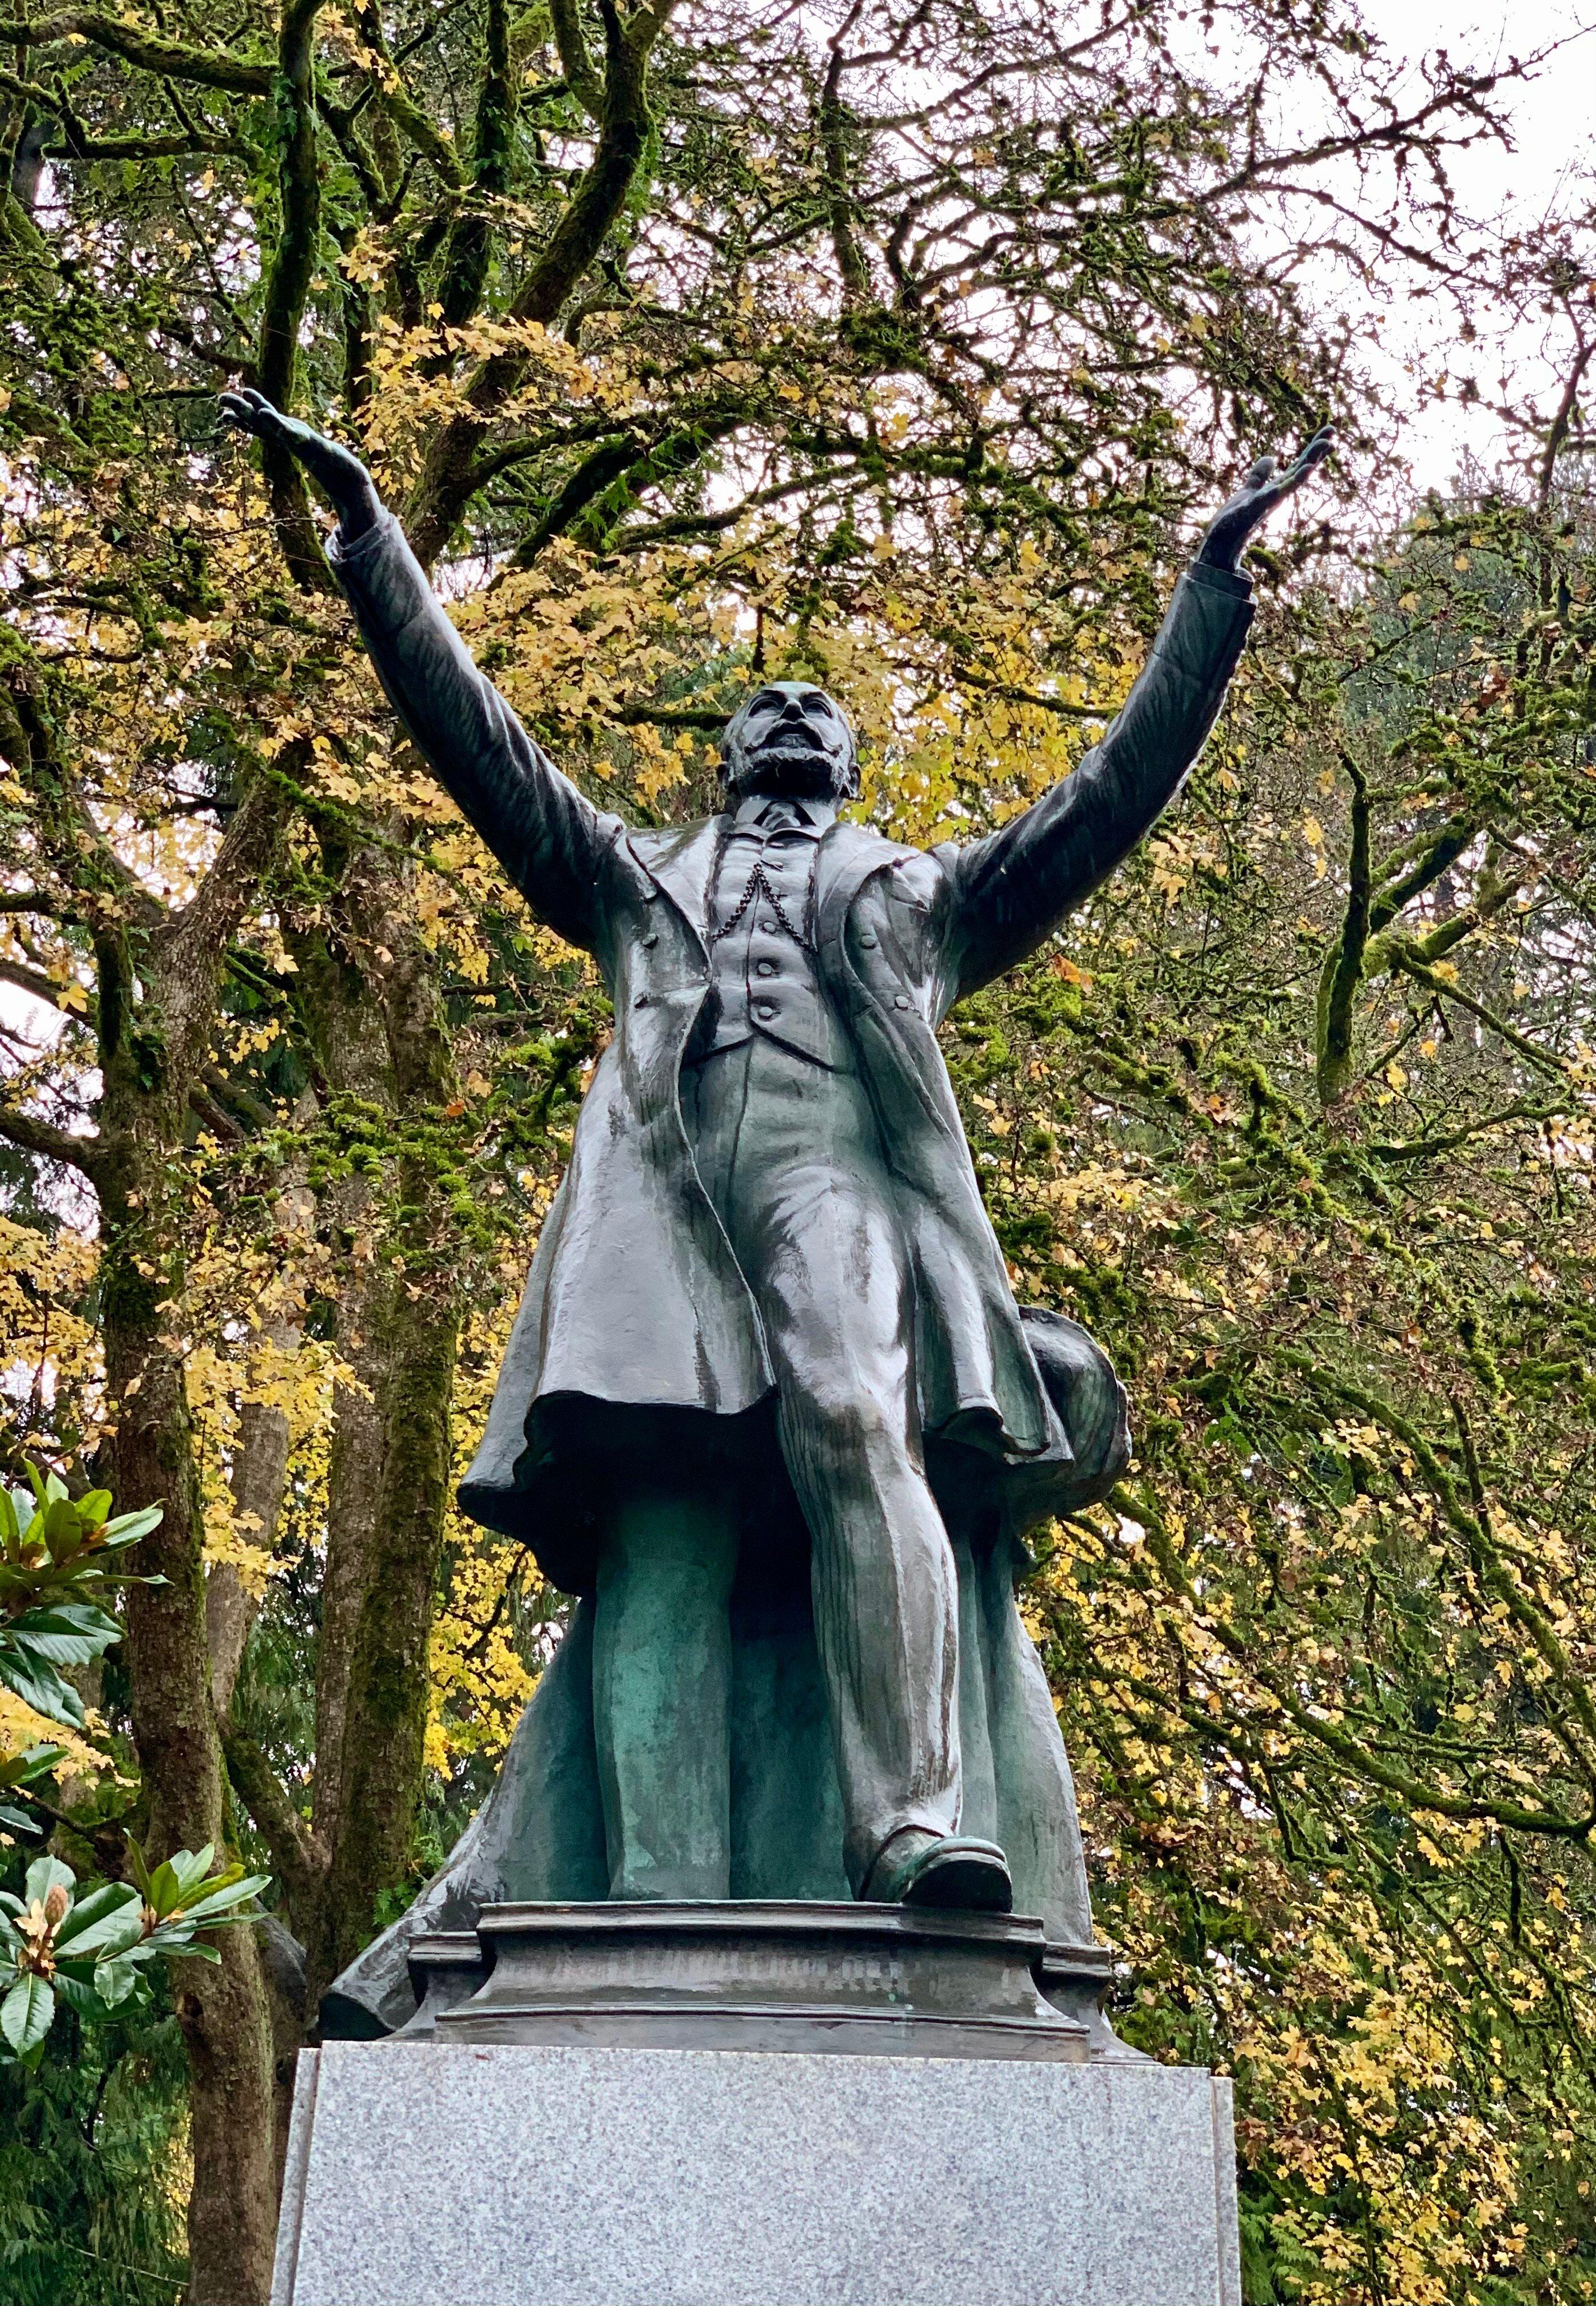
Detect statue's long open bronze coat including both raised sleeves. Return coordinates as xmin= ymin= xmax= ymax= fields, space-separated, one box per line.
xmin=332 ymin=514 xmax=1252 ymax=1582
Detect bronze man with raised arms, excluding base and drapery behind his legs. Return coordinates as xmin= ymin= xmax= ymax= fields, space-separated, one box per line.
xmin=221 ymin=392 xmax=1331 ymax=2020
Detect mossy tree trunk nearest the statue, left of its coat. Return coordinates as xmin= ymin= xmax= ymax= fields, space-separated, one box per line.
xmin=295 ymin=846 xmax=463 ymax=2013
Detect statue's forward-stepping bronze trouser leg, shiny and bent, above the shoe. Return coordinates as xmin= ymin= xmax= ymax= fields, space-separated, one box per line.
xmin=690 ymin=1040 xmax=959 ymax=1891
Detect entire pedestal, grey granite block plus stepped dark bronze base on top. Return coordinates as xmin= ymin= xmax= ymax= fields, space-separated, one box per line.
xmin=272 ymin=1905 xmax=1241 ymax=2306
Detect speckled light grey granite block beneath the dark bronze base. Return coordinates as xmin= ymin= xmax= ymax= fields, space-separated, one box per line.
xmin=272 ymin=2036 xmax=1241 ymax=2306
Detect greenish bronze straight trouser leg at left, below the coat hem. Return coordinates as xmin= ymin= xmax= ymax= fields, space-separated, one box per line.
xmin=593 ymin=1469 xmax=738 ymax=1900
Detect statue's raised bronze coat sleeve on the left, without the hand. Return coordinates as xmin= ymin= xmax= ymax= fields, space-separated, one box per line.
xmin=328 ymin=512 xmax=621 ymax=946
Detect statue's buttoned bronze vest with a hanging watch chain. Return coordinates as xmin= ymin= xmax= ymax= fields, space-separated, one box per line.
xmin=690 ymin=825 xmax=853 ymax=1072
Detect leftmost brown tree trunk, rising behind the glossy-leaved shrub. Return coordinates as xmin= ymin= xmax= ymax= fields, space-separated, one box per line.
xmin=94 ymin=793 xmax=281 ymax=2306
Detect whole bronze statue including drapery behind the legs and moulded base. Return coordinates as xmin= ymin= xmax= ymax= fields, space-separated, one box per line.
xmin=221 ymin=390 xmax=1328 ymax=2055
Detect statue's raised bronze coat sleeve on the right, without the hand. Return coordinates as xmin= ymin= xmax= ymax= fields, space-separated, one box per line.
xmin=936 ymin=563 xmax=1252 ymax=998
